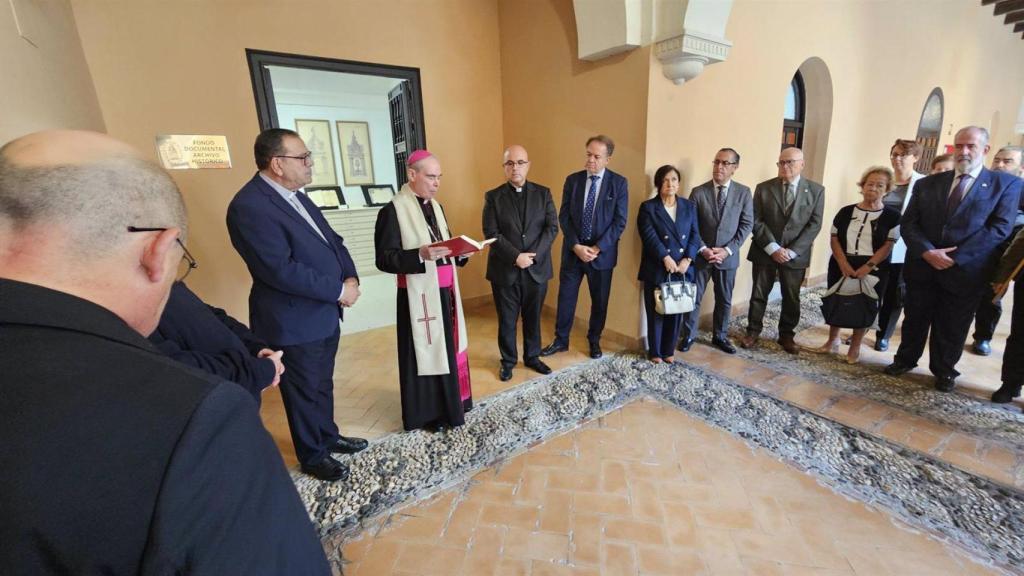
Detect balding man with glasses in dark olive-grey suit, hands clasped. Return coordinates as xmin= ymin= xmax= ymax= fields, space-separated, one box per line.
xmin=739 ymin=148 xmax=825 ymax=354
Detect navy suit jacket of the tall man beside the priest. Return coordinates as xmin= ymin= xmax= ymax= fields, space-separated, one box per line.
xmin=558 ymin=168 xmax=629 ymax=270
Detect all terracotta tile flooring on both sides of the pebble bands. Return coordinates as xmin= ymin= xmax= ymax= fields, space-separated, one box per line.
xmin=261 ymin=289 xmax=1024 ymax=575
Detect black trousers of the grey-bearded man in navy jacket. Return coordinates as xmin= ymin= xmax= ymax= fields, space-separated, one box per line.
xmin=894 ymin=276 xmax=982 ymax=378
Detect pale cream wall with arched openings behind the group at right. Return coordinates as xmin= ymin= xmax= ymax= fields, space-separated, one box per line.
xmin=645 ymin=0 xmax=1024 ymax=330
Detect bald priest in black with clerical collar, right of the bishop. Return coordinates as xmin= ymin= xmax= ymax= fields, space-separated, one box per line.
xmin=483 ymin=146 xmax=558 ymax=381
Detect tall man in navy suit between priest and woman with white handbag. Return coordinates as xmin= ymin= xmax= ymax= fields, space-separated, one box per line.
xmin=541 ymin=134 xmax=629 ymax=358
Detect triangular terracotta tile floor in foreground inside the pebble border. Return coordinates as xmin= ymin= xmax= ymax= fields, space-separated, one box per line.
xmin=344 ymin=401 xmax=996 ymax=576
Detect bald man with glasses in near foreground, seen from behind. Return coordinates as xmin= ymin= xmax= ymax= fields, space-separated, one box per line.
xmin=0 ymin=131 xmax=330 ymax=574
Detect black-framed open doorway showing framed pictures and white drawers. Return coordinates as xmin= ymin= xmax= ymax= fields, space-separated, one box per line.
xmin=246 ymin=50 xmax=426 ymax=335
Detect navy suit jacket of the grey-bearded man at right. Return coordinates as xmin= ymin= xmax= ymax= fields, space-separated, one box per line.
xmin=900 ymin=168 xmax=1021 ymax=293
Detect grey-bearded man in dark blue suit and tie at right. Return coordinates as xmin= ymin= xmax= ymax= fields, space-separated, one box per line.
xmin=885 ymin=126 xmax=1021 ymax=392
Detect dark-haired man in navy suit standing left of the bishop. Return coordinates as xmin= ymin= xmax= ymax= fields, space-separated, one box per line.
xmin=227 ymin=128 xmax=367 ymax=481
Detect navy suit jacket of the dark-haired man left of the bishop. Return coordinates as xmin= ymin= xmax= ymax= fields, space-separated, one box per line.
xmin=227 ymin=173 xmax=357 ymax=345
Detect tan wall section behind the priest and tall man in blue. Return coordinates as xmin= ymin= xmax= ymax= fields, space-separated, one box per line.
xmin=492 ymin=0 xmax=650 ymax=342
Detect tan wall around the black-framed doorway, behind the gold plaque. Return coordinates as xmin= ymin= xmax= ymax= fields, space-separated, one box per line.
xmin=73 ymin=0 xmax=502 ymax=318
